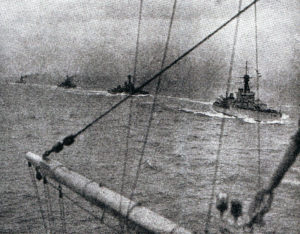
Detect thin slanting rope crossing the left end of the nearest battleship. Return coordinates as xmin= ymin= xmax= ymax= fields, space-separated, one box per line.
xmin=205 ymin=0 xmax=242 ymax=233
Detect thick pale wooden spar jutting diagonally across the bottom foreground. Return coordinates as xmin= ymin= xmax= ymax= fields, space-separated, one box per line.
xmin=26 ymin=152 xmax=192 ymax=234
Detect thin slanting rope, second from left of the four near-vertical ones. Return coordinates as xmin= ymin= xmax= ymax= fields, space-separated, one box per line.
xmin=127 ymin=0 xmax=177 ymax=216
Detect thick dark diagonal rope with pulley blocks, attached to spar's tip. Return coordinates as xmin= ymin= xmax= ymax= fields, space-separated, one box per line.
xmin=43 ymin=0 xmax=259 ymax=159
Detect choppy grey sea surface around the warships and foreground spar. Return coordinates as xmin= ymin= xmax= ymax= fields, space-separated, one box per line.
xmin=0 ymin=83 xmax=300 ymax=233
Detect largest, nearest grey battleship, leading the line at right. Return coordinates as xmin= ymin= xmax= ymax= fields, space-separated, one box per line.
xmin=213 ymin=62 xmax=282 ymax=121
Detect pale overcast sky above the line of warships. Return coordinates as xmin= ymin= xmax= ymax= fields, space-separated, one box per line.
xmin=0 ymin=0 xmax=300 ymax=102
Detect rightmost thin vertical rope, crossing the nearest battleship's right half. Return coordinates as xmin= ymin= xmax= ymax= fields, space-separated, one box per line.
xmin=254 ymin=3 xmax=261 ymax=189
